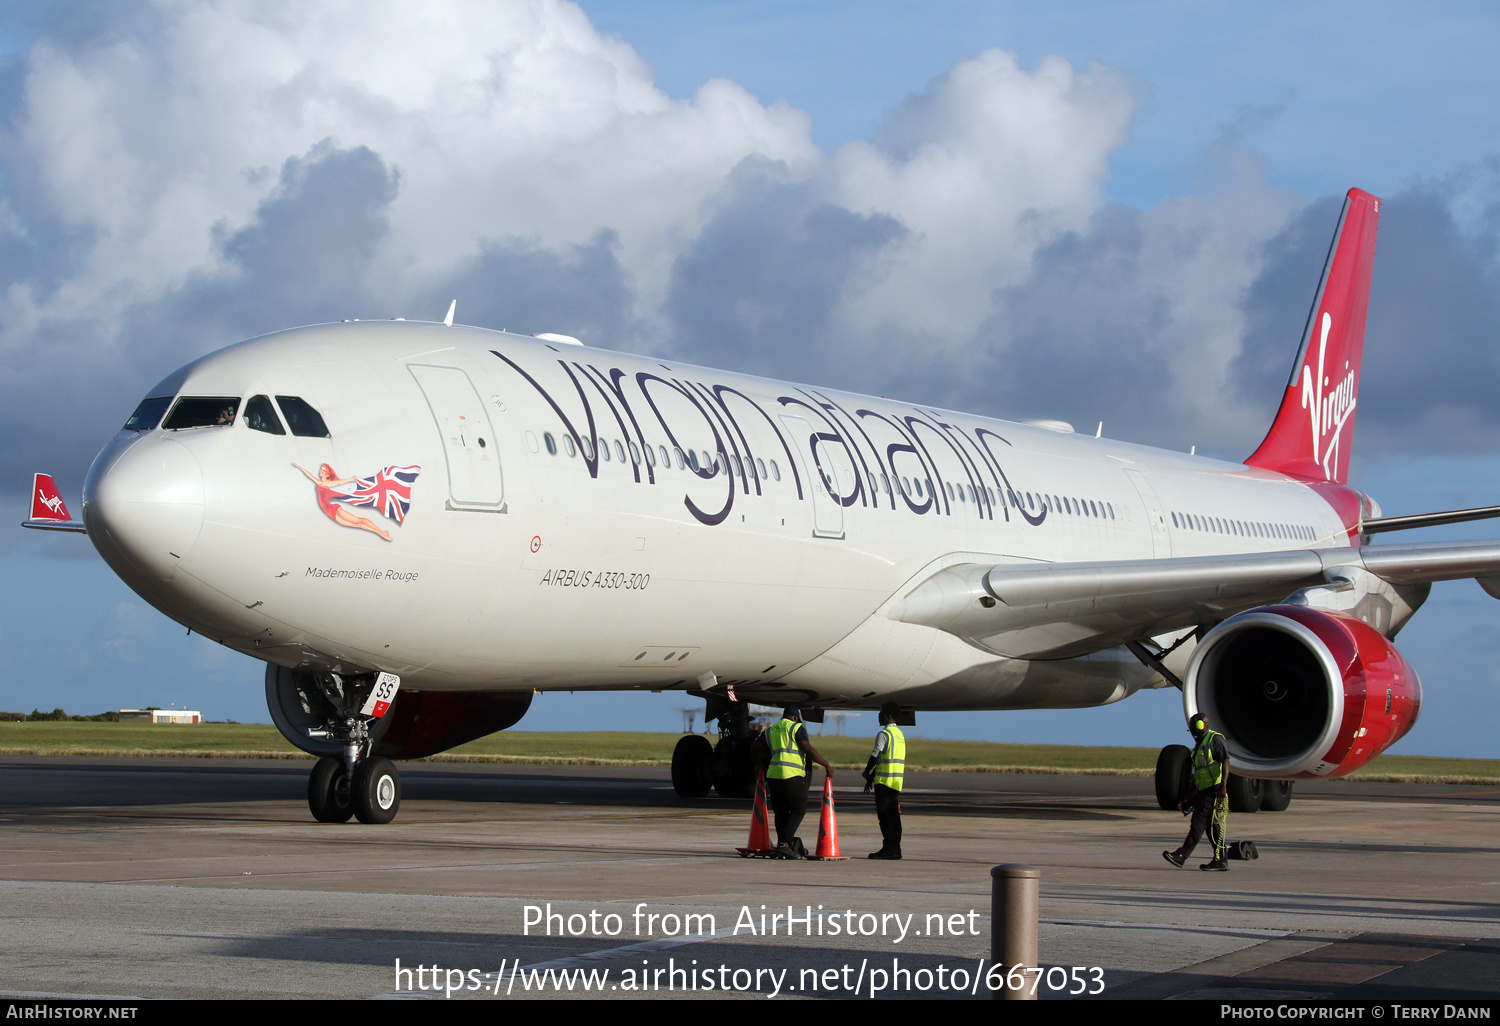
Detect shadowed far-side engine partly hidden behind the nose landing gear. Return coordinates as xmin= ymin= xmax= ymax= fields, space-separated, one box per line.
xmin=266 ymin=663 xmax=531 ymax=759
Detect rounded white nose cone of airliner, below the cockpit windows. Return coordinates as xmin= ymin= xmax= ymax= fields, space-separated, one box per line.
xmin=84 ymin=438 xmax=204 ymax=579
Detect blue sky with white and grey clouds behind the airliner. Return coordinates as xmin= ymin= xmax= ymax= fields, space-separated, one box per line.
xmin=0 ymin=0 xmax=1500 ymax=756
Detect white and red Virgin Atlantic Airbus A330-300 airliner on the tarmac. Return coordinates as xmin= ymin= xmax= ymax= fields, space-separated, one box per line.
xmin=27 ymin=189 xmax=1500 ymax=822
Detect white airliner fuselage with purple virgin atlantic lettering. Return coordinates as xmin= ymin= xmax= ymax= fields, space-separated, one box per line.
xmin=84 ymin=321 xmax=1352 ymax=708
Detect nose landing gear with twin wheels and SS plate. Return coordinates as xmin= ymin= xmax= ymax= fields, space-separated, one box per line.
xmin=308 ymin=674 xmax=401 ymax=824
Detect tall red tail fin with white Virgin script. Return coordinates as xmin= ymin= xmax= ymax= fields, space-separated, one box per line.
xmin=1245 ymin=189 xmax=1380 ymax=485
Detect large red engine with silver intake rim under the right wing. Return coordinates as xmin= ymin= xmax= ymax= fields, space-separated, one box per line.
xmin=1184 ymin=606 xmax=1422 ymax=780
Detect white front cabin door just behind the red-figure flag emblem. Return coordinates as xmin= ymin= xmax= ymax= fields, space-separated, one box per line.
xmin=407 ymin=363 xmax=506 ymax=513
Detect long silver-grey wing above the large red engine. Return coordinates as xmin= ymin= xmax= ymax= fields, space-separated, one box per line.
xmin=888 ymin=542 xmax=1500 ymax=659
